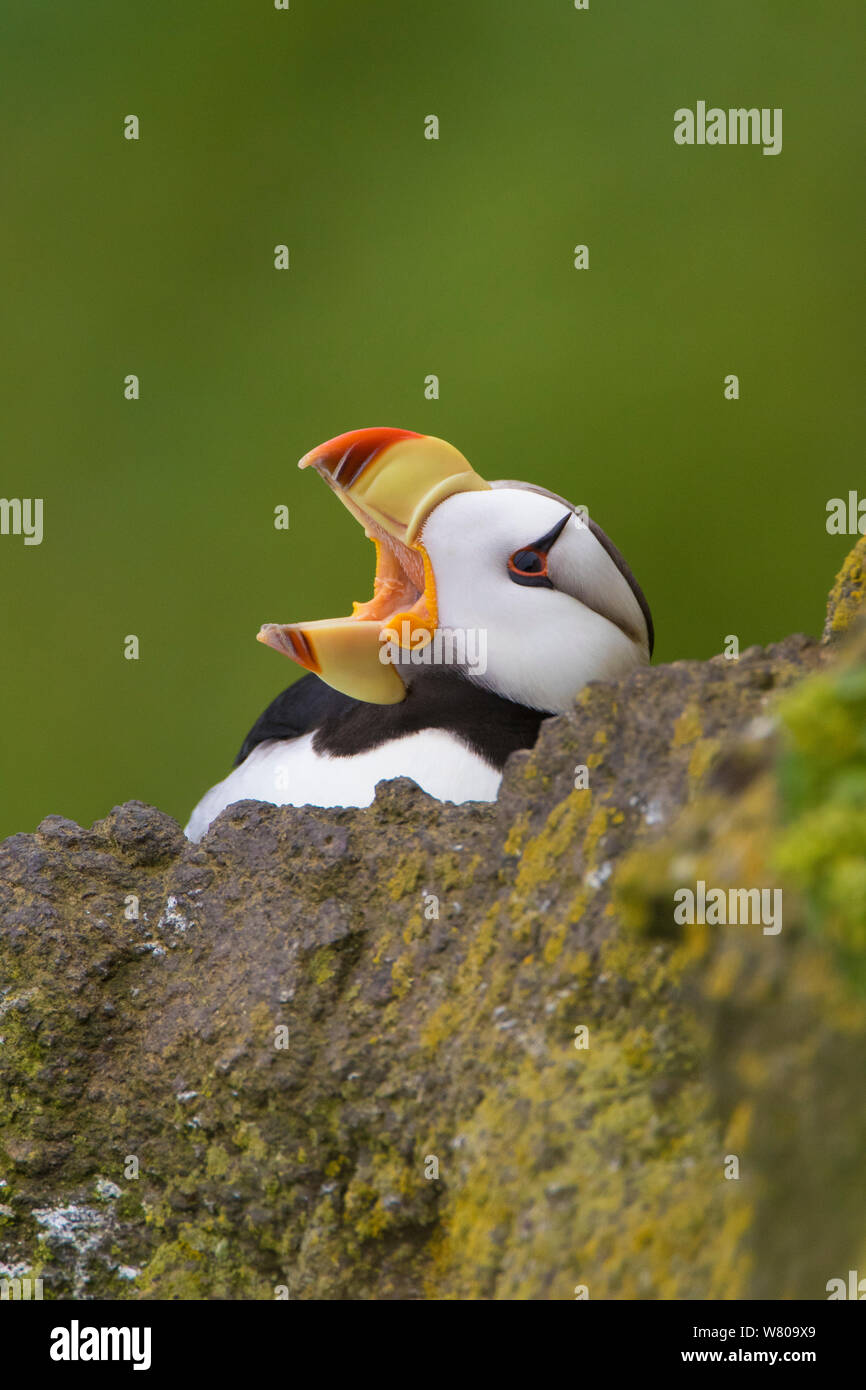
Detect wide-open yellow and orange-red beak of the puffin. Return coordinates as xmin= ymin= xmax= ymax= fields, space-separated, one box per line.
xmin=259 ymin=430 xmax=489 ymax=705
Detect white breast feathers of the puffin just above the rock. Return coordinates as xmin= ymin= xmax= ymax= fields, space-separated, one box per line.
xmin=186 ymin=728 xmax=502 ymax=840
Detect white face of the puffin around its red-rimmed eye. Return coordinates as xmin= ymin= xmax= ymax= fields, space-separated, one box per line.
xmin=420 ymin=487 xmax=649 ymax=712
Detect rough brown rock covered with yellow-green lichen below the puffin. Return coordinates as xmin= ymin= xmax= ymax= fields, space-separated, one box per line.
xmin=0 ymin=542 xmax=866 ymax=1298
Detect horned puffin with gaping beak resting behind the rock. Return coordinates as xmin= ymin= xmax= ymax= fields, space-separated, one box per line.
xmin=186 ymin=428 xmax=653 ymax=841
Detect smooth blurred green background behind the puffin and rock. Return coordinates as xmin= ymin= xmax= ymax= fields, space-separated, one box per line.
xmin=0 ymin=0 xmax=866 ymax=834
